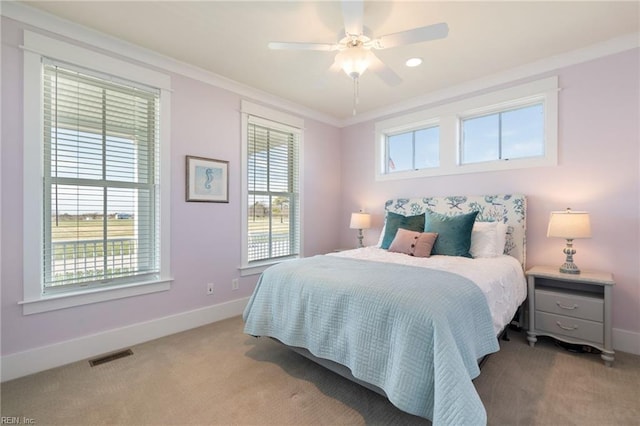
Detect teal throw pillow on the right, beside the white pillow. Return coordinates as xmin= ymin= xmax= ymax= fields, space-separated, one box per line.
xmin=424 ymin=210 xmax=478 ymax=257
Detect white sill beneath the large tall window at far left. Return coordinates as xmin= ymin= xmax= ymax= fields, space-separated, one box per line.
xmin=18 ymin=278 xmax=173 ymax=315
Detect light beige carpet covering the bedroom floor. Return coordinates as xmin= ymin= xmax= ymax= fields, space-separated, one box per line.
xmin=0 ymin=317 xmax=640 ymax=425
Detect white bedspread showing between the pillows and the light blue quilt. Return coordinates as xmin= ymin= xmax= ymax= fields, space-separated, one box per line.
xmin=331 ymin=246 xmax=527 ymax=335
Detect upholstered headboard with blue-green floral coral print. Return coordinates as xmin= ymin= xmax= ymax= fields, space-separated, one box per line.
xmin=384 ymin=194 xmax=527 ymax=267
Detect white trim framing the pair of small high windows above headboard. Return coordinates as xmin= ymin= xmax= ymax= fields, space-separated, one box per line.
xmin=375 ymin=76 xmax=558 ymax=181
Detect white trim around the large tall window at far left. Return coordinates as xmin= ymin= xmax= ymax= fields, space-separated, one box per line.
xmin=18 ymin=31 xmax=172 ymax=315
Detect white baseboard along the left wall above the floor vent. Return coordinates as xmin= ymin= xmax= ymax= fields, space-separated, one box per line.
xmin=0 ymin=298 xmax=249 ymax=382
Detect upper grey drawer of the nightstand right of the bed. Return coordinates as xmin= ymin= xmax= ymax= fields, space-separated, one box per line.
xmin=535 ymin=289 xmax=604 ymax=322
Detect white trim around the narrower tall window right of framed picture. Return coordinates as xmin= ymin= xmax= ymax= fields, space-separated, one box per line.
xmin=238 ymin=100 xmax=304 ymax=276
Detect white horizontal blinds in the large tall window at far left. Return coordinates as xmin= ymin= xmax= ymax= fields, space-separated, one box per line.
xmin=43 ymin=60 xmax=160 ymax=293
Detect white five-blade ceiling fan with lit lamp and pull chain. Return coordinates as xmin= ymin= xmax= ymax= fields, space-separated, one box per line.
xmin=268 ymin=0 xmax=449 ymax=115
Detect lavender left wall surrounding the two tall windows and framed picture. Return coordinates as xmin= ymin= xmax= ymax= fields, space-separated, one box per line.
xmin=1 ymin=18 xmax=343 ymax=355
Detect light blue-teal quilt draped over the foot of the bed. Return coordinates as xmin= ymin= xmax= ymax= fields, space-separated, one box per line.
xmin=243 ymin=256 xmax=499 ymax=425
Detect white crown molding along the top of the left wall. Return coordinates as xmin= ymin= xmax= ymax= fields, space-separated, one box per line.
xmin=0 ymin=0 xmax=341 ymax=127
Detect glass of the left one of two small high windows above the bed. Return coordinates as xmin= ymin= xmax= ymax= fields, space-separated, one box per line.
xmin=387 ymin=126 xmax=440 ymax=173
